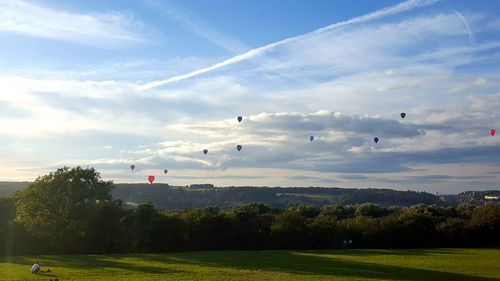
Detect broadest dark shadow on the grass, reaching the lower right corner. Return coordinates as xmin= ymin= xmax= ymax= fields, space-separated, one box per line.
xmin=135 ymin=251 xmax=500 ymax=281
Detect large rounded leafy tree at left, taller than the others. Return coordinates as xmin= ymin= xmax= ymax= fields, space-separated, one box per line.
xmin=15 ymin=167 xmax=112 ymax=252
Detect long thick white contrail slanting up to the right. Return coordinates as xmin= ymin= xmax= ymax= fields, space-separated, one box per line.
xmin=137 ymin=0 xmax=438 ymax=91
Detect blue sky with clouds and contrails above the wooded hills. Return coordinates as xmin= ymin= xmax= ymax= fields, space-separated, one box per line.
xmin=0 ymin=0 xmax=500 ymax=194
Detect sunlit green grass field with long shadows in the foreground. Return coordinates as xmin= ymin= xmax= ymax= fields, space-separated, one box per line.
xmin=0 ymin=249 xmax=500 ymax=281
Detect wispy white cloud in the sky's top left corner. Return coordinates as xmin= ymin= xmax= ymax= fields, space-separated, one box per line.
xmin=0 ymin=0 xmax=147 ymax=47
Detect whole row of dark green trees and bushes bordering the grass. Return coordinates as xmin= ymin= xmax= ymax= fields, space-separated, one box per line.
xmin=0 ymin=167 xmax=500 ymax=255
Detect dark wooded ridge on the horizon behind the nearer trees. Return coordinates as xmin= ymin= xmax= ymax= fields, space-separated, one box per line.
xmin=0 ymin=182 xmax=500 ymax=210
